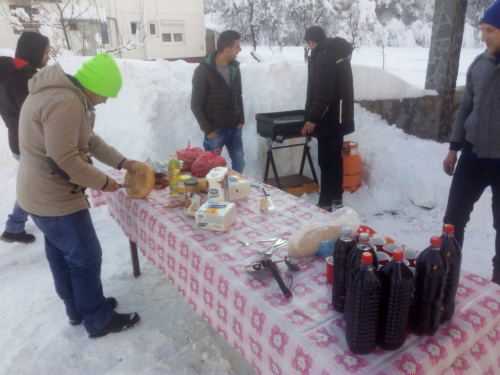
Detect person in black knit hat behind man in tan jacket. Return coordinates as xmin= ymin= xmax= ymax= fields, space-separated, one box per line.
xmin=0 ymin=32 xmax=50 ymax=243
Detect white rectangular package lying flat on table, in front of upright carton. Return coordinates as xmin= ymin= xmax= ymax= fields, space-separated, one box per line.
xmin=195 ymin=201 xmax=236 ymax=232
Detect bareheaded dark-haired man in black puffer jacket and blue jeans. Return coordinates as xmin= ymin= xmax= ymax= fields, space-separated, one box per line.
xmin=191 ymin=30 xmax=245 ymax=173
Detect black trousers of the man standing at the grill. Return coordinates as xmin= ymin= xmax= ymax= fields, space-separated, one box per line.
xmin=318 ymin=137 xmax=344 ymax=206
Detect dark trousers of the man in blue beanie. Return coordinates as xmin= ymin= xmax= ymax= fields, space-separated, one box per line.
xmin=443 ymin=155 xmax=500 ymax=270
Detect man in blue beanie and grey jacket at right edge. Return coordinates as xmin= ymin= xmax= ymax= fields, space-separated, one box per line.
xmin=443 ymin=1 xmax=500 ymax=284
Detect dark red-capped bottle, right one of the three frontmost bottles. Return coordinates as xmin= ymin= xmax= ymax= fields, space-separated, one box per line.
xmin=410 ymin=236 xmax=448 ymax=336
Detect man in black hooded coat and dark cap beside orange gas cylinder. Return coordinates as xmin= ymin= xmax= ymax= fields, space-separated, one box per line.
xmin=302 ymin=26 xmax=354 ymax=212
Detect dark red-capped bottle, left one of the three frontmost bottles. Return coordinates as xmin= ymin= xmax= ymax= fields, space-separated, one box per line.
xmin=344 ymin=252 xmax=381 ymax=354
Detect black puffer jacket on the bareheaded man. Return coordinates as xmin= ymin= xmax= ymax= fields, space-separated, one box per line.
xmin=191 ymin=51 xmax=245 ymax=134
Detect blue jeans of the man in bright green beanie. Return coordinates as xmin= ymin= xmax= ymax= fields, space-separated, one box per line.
xmin=31 ymin=210 xmax=115 ymax=333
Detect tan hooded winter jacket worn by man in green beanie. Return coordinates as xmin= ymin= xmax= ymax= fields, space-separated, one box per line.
xmin=17 ymin=64 xmax=125 ymax=216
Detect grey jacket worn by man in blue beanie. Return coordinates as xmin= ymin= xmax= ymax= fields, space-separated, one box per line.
xmin=450 ymin=51 xmax=500 ymax=159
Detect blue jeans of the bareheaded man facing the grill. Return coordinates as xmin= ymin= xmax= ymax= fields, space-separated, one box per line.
xmin=203 ymin=126 xmax=245 ymax=173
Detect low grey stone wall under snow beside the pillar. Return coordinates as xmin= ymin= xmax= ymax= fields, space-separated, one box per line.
xmin=357 ymin=86 xmax=464 ymax=142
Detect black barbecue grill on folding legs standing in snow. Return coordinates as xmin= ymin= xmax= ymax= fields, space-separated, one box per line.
xmin=255 ymin=110 xmax=319 ymax=195
